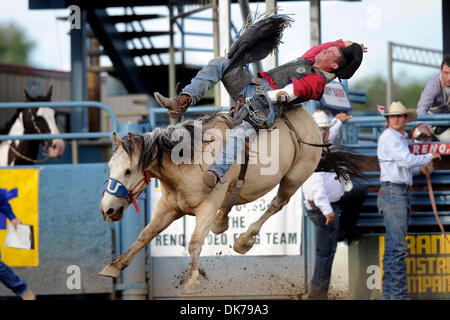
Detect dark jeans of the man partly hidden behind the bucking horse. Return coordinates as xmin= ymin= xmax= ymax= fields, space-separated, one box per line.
xmin=306 ymin=202 xmax=341 ymax=299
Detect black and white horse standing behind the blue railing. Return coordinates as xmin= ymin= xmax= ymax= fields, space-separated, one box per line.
xmin=0 ymin=87 xmax=65 ymax=167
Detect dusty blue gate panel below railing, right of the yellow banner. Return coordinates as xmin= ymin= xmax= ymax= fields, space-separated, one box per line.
xmin=0 ymin=163 xmax=113 ymax=296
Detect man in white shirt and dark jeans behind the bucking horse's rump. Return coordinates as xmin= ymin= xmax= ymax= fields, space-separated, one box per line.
xmin=303 ymin=110 xmax=351 ymax=300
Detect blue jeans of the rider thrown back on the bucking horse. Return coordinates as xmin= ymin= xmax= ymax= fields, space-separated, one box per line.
xmin=181 ymin=57 xmax=270 ymax=177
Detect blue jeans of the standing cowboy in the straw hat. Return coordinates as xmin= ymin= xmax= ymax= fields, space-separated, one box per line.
xmin=377 ymin=182 xmax=411 ymax=300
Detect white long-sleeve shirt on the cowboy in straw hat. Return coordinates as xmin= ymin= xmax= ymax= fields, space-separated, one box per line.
xmin=377 ymin=127 xmax=433 ymax=186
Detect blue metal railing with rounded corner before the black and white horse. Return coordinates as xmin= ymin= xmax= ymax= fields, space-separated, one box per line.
xmin=0 ymin=101 xmax=119 ymax=163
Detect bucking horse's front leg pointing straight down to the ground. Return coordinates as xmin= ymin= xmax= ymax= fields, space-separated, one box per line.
xmin=183 ymin=204 xmax=217 ymax=294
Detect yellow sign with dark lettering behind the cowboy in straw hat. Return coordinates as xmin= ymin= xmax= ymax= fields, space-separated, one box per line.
xmin=379 ymin=234 xmax=450 ymax=294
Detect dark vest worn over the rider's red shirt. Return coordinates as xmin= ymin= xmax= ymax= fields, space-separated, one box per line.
xmin=267 ymin=58 xmax=327 ymax=98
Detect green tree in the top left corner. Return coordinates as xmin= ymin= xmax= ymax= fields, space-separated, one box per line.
xmin=0 ymin=23 xmax=35 ymax=65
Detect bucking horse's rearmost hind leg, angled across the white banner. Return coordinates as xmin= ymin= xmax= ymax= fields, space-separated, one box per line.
xmin=233 ymin=177 xmax=300 ymax=254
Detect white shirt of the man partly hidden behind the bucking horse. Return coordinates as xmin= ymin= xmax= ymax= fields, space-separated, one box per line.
xmin=303 ymin=119 xmax=345 ymax=216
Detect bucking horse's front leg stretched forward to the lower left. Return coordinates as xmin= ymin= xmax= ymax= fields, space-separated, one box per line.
xmin=99 ymin=197 xmax=183 ymax=278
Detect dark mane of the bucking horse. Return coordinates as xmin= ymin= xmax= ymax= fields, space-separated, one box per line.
xmin=122 ymin=110 xmax=220 ymax=170
